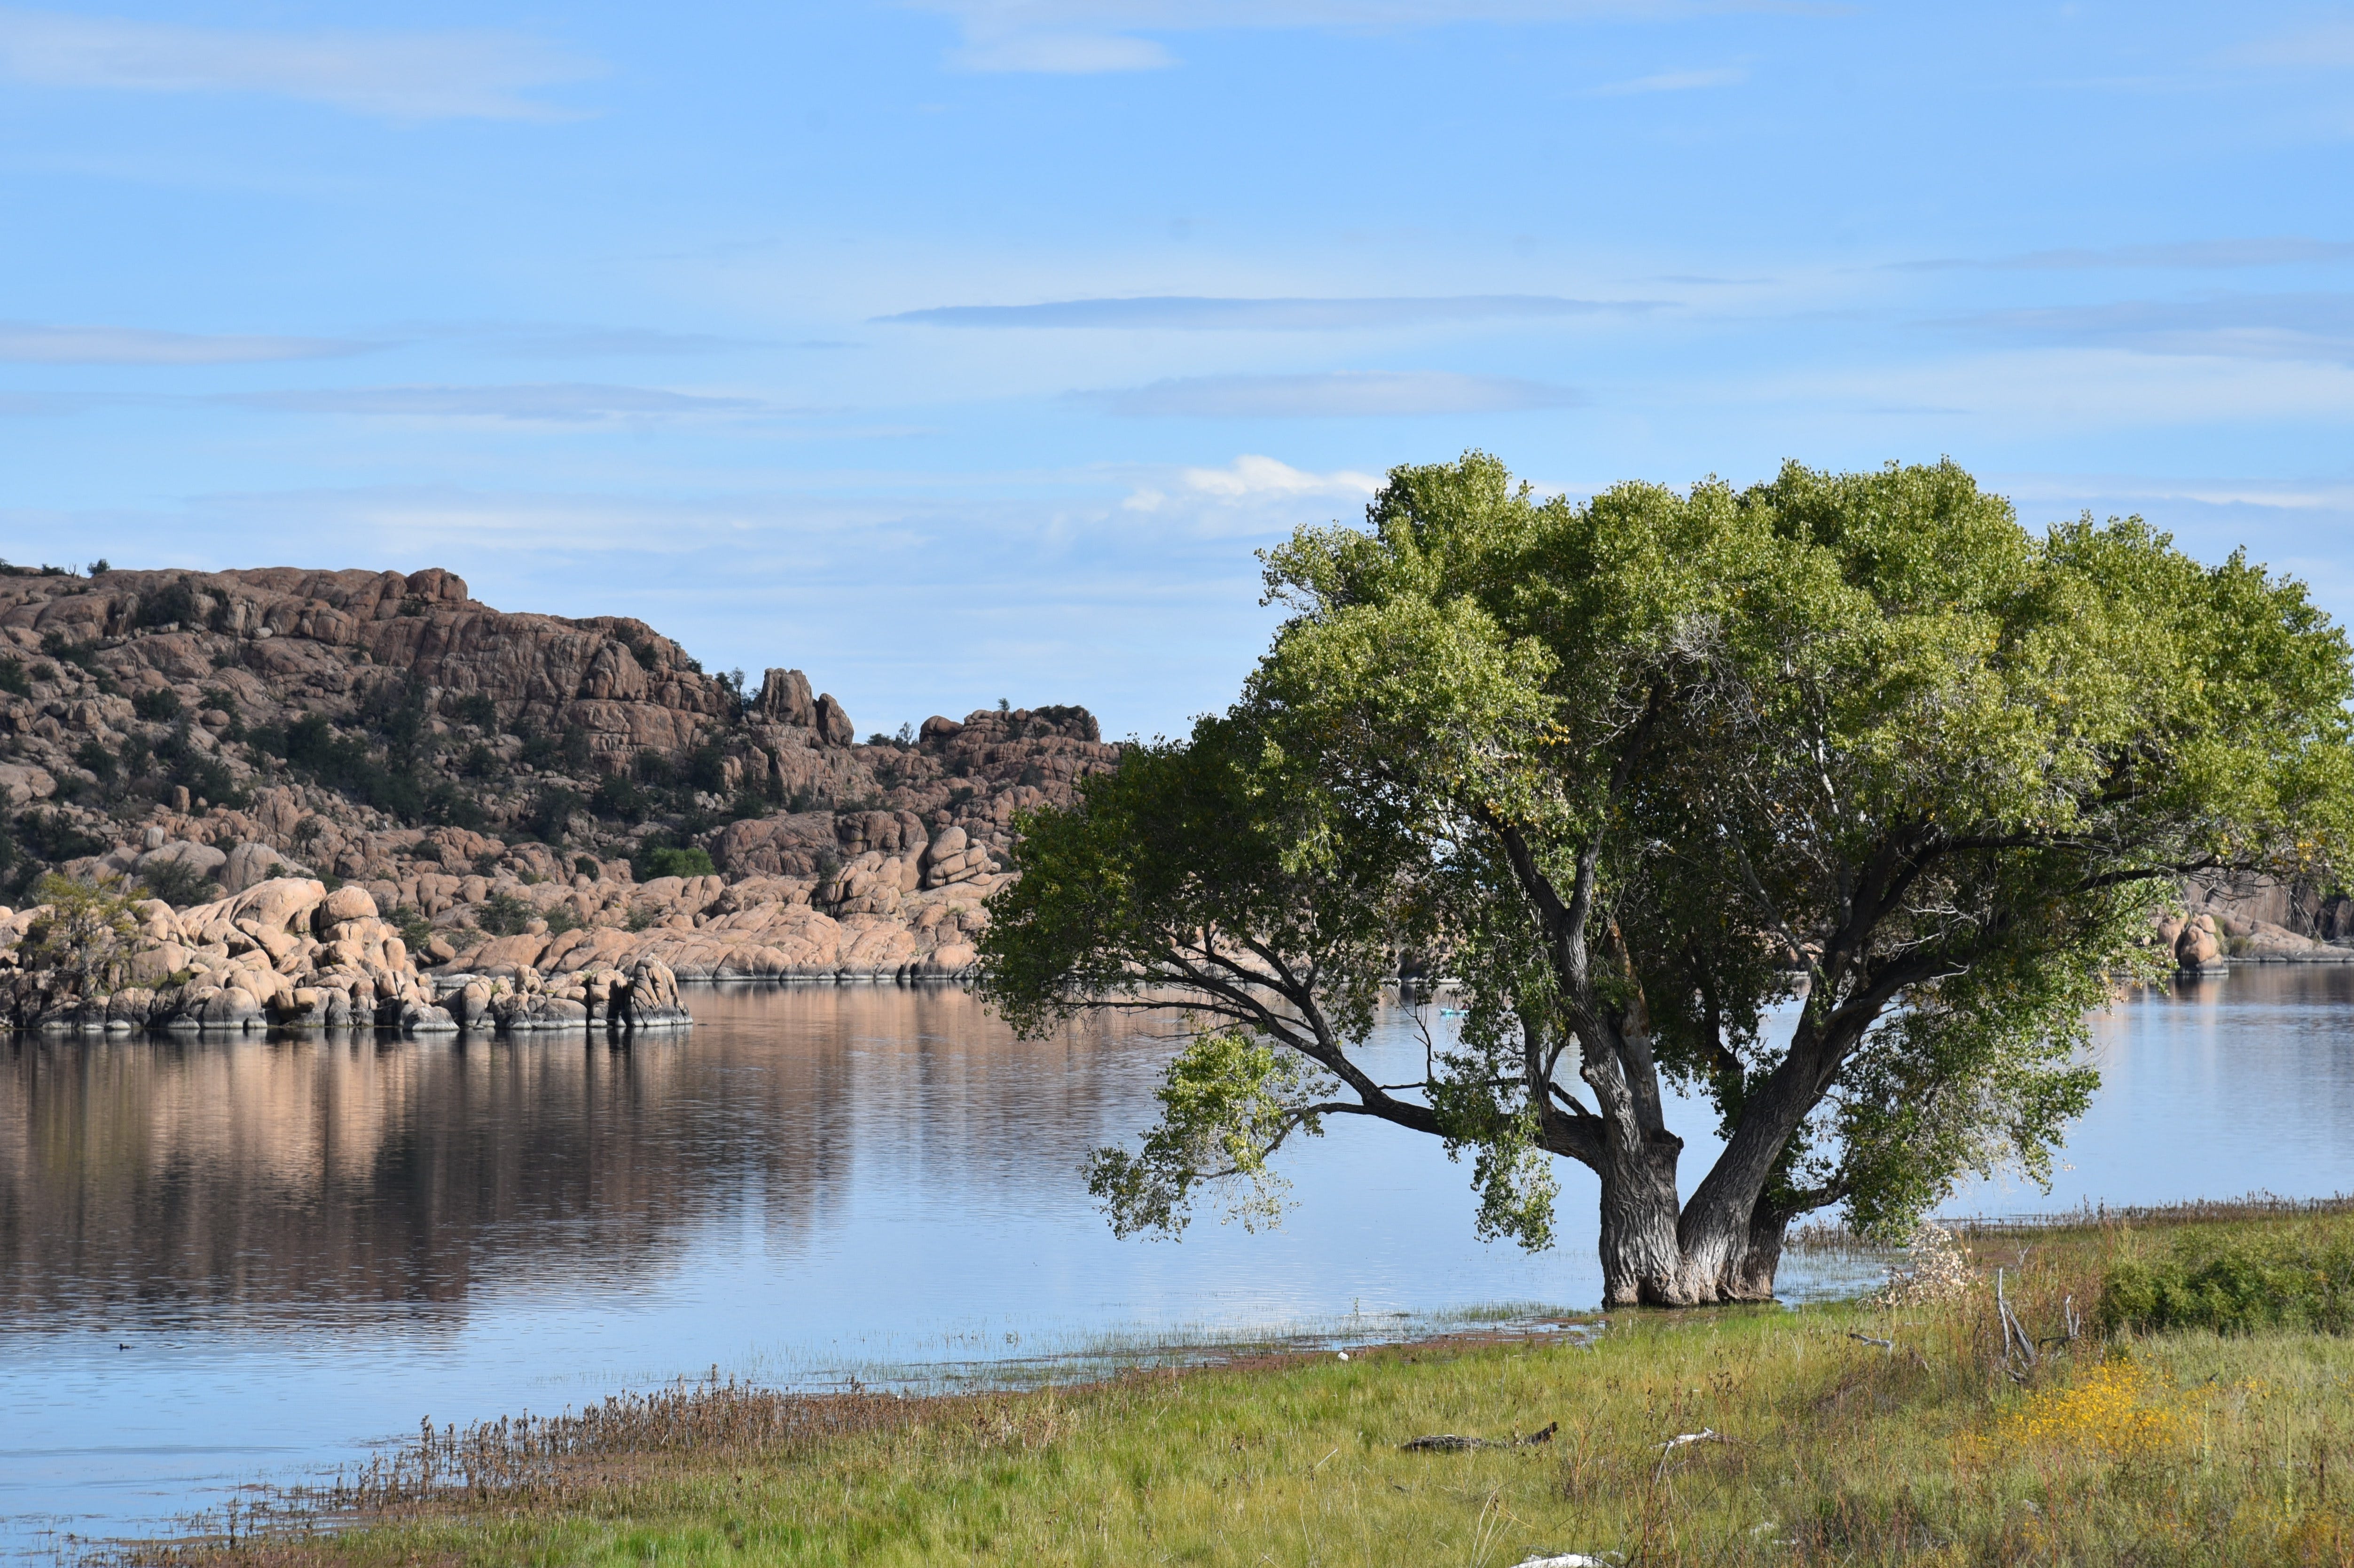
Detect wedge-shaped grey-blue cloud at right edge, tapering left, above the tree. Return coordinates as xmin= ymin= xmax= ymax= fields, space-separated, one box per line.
xmin=1945 ymin=294 xmax=2354 ymax=362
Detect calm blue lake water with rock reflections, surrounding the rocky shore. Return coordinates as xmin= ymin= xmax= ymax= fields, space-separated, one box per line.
xmin=0 ymin=968 xmax=2354 ymax=1554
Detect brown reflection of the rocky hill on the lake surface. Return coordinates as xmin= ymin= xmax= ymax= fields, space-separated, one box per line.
xmin=0 ymin=987 xmax=1156 ymax=1328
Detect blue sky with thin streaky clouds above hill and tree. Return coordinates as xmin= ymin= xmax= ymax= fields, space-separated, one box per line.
xmin=0 ymin=0 xmax=2354 ymax=737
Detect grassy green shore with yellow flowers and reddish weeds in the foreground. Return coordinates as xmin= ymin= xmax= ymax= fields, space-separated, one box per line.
xmin=106 ymin=1199 xmax=2354 ymax=1568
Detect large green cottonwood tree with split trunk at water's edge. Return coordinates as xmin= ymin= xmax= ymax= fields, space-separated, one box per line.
xmin=981 ymin=455 xmax=2354 ymax=1304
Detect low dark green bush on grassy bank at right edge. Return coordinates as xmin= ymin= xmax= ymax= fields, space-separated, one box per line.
xmin=2097 ymin=1222 xmax=2354 ymax=1335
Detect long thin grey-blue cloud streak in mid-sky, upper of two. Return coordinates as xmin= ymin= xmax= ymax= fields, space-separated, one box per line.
xmin=876 ymin=294 xmax=1662 ymax=332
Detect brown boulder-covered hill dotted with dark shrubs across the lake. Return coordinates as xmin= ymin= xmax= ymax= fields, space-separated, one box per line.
xmin=0 ymin=567 xmax=1118 ymax=987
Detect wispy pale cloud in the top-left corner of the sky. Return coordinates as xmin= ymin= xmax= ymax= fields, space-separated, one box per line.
xmin=0 ymin=7 xmax=598 ymax=120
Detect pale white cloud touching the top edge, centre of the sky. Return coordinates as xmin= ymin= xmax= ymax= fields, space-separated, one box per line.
xmin=909 ymin=0 xmax=1721 ymax=73
